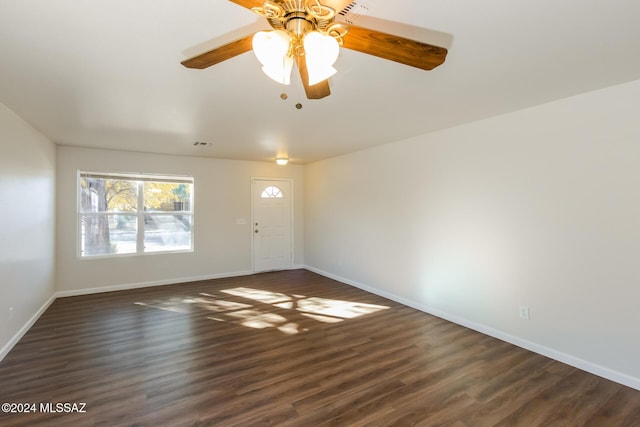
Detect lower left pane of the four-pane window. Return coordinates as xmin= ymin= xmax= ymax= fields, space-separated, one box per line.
xmin=80 ymin=214 xmax=137 ymax=256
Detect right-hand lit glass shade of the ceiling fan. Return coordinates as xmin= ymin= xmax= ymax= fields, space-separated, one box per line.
xmin=304 ymin=31 xmax=340 ymax=85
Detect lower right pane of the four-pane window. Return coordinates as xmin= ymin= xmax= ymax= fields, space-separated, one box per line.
xmin=144 ymin=214 xmax=191 ymax=252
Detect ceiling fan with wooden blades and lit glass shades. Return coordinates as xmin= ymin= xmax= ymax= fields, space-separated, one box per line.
xmin=182 ymin=0 xmax=447 ymax=99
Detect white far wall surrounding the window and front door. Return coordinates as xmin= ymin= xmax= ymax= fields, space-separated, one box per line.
xmin=56 ymin=146 xmax=304 ymax=295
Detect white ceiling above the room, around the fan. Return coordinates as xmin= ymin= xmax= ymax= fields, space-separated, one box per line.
xmin=0 ymin=0 xmax=640 ymax=164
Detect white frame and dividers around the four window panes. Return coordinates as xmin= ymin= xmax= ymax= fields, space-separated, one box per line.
xmin=76 ymin=170 xmax=195 ymax=260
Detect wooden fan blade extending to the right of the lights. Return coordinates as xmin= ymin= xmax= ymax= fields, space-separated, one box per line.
xmin=342 ymin=25 xmax=447 ymax=70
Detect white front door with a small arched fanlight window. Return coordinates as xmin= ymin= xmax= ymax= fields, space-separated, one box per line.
xmin=251 ymin=179 xmax=293 ymax=271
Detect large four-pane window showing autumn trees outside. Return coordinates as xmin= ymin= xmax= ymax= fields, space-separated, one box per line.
xmin=78 ymin=172 xmax=193 ymax=257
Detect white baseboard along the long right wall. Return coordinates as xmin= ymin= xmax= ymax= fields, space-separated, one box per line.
xmin=304 ymin=266 xmax=640 ymax=390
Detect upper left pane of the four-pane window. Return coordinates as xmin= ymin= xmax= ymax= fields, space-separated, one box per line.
xmin=80 ymin=177 xmax=138 ymax=212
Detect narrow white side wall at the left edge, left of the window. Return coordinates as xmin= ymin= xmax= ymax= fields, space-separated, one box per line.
xmin=0 ymin=104 xmax=55 ymax=359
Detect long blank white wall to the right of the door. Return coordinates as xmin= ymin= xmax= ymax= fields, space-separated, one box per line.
xmin=304 ymin=81 xmax=640 ymax=389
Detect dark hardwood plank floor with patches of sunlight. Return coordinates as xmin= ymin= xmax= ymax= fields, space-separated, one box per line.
xmin=0 ymin=270 xmax=640 ymax=427
